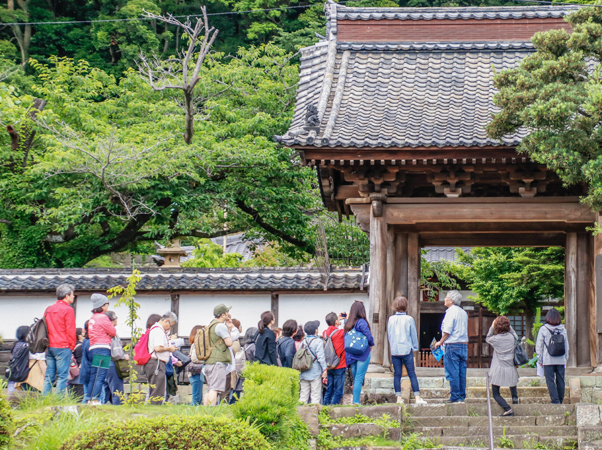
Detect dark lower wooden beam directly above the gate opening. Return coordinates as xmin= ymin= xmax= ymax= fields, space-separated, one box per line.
xmin=420 ymin=232 xmax=566 ymax=247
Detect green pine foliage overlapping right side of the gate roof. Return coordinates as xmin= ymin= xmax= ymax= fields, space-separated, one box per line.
xmin=487 ymin=8 xmax=602 ymax=210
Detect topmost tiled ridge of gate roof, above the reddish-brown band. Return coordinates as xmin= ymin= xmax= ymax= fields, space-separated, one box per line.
xmin=337 ymin=5 xmax=582 ymax=20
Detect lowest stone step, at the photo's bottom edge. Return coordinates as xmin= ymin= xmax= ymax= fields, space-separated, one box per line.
xmin=426 ymin=433 xmax=577 ymax=449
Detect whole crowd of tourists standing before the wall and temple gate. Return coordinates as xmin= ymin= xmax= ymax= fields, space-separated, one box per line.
xmin=8 ymin=284 xmax=569 ymax=410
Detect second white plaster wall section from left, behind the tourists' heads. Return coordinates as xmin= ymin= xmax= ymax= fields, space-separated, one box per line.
xmin=75 ymin=295 xmax=171 ymax=338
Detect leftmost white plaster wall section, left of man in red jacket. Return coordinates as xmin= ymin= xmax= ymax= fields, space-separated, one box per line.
xmin=0 ymin=295 xmax=56 ymax=339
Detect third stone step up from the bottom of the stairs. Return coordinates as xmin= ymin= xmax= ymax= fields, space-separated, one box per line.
xmin=403 ymin=415 xmax=571 ymax=428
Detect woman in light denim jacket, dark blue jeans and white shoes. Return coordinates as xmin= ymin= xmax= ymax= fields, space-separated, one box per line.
xmin=387 ymin=297 xmax=426 ymax=405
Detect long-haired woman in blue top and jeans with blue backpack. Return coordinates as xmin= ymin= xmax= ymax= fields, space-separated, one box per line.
xmin=345 ymin=300 xmax=374 ymax=405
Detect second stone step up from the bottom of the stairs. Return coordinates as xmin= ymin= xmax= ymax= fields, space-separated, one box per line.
xmin=402 ymin=425 xmax=577 ymax=438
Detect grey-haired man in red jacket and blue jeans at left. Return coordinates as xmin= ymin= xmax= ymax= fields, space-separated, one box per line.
xmin=44 ymin=284 xmax=77 ymax=395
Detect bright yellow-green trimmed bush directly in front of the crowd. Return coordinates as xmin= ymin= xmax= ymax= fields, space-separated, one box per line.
xmin=233 ymin=363 xmax=299 ymax=440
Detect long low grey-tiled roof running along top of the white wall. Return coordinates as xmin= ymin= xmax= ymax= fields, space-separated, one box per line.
xmin=0 ymin=268 xmax=368 ymax=292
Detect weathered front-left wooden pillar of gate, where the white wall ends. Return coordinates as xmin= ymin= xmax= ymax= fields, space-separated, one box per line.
xmin=367 ymin=196 xmax=387 ymax=364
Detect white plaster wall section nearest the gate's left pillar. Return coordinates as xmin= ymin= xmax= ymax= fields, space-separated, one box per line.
xmin=278 ymin=291 xmax=368 ymax=331
